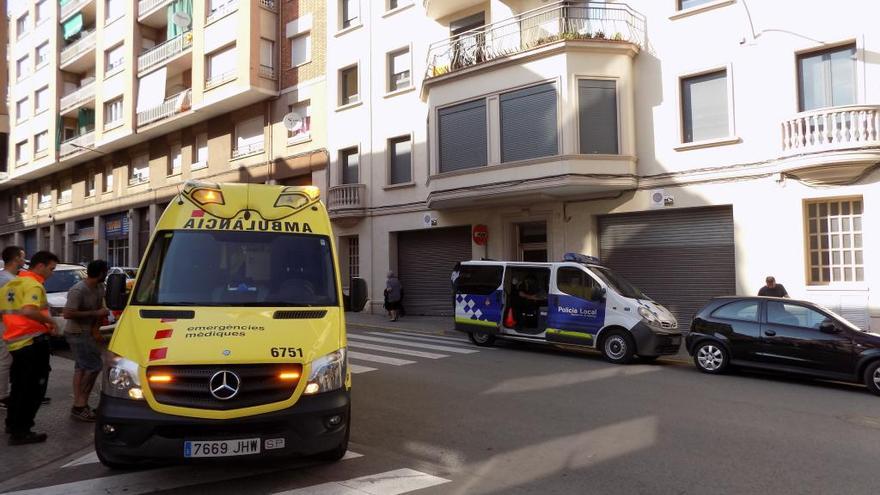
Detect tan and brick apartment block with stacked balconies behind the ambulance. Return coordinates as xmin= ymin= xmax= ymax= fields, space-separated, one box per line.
xmin=0 ymin=0 xmax=326 ymax=266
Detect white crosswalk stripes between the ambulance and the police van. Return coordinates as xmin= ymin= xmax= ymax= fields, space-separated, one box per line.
xmin=348 ymin=331 xmax=480 ymax=374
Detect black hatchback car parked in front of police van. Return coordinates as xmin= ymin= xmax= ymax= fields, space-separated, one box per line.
xmin=685 ymin=297 xmax=880 ymax=395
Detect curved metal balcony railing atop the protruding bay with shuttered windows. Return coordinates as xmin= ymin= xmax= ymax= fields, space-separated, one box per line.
xmin=425 ymin=1 xmax=646 ymax=78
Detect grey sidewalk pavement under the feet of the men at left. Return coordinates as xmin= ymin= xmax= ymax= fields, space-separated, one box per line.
xmin=0 ymin=355 xmax=98 ymax=482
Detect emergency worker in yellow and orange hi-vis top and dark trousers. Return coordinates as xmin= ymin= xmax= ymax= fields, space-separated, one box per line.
xmin=0 ymin=251 xmax=58 ymax=445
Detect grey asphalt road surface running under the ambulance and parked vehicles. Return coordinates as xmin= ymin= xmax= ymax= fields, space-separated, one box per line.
xmin=0 ymin=329 xmax=880 ymax=495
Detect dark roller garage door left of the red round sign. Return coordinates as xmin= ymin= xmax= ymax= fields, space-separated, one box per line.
xmin=397 ymin=226 xmax=471 ymax=316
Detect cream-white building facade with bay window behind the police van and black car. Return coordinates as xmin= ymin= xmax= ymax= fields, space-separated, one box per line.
xmin=327 ymin=0 xmax=880 ymax=330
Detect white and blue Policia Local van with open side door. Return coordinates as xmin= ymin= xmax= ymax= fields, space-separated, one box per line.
xmin=452 ymin=253 xmax=682 ymax=364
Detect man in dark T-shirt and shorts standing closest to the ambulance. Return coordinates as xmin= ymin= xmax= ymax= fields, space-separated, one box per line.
xmin=64 ymin=260 xmax=110 ymax=422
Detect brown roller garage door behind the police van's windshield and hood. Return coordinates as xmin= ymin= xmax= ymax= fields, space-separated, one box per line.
xmin=599 ymin=207 xmax=736 ymax=330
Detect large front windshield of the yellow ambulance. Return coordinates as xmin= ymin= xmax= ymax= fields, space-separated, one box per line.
xmin=135 ymin=231 xmax=337 ymax=306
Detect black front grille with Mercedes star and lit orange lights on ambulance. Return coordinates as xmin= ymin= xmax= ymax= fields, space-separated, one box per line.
xmin=147 ymin=363 xmax=302 ymax=411
